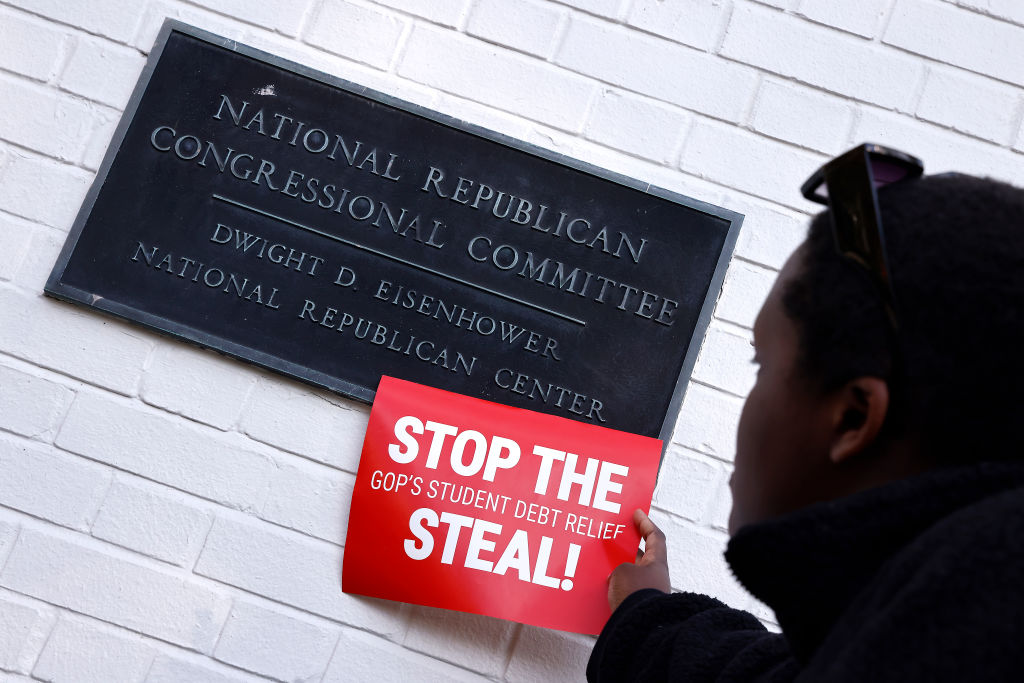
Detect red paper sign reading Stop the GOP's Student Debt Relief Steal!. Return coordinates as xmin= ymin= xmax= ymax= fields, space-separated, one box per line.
xmin=342 ymin=377 xmax=662 ymax=633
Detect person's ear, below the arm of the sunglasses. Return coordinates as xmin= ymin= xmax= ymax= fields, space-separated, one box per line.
xmin=828 ymin=377 xmax=889 ymax=464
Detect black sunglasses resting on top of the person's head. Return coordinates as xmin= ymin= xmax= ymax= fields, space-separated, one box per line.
xmin=800 ymin=144 xmax=925 ymax=334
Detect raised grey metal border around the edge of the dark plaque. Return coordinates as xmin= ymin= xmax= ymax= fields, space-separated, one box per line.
xmin=44 ymin=17 xmax=743 ymax=448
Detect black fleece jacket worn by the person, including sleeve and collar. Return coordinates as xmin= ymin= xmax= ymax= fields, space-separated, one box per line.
xmin=587 ymin=463 xmax=1024 ymax=683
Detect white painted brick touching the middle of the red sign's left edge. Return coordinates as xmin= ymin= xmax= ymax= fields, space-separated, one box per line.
xmin=259 ymin=458 xmax=355 ymax=545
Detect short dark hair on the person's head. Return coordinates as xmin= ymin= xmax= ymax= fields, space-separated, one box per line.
xmin=782 ymin=174 xmax=1024 ymax=463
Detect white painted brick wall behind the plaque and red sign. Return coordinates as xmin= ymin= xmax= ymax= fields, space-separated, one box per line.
xmin=0 ymin=0 xmax=1024 ymax=683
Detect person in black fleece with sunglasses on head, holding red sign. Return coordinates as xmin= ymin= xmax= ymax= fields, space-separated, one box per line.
xmin=587 ymin=145 xmax=1024 ymax=683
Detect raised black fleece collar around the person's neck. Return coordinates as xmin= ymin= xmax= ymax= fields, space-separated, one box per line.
xmin=725 ymin=463 xmax=1024 ymax=663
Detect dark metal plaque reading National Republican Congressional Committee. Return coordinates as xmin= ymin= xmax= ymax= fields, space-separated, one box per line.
xmin=46 ymin=22 xmax=741 ymax=438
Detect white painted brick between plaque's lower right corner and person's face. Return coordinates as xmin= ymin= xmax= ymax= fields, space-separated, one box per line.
xmin=673 ymin=385 xmax=753 ymax=460
